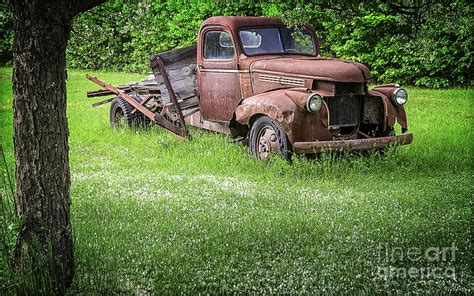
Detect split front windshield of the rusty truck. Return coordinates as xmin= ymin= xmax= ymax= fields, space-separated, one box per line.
xmin=239 ymin=28 xmax=316 ymax=55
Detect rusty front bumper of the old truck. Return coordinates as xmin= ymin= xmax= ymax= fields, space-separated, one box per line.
xmin=293 ymin=134 xmax=413 ymax=154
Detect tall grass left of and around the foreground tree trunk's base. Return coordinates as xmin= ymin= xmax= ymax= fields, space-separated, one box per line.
xmin=0 ymin=73 xmax=64 ymax=295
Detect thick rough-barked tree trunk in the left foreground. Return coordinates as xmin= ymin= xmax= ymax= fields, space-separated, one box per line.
xmin=12 ymin=0 xmax=74 ymax=291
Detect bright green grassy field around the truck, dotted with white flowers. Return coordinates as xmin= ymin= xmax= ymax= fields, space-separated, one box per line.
xmin=0 ymin=68 xmax=474 ymax=294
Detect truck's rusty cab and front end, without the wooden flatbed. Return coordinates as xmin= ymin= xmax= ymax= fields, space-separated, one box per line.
xmin=193 ymin=16 xmax=412 ymax=159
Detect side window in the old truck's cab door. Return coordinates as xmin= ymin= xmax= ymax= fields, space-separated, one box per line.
xmin=204 ymin=31 xmax=235 ymax=60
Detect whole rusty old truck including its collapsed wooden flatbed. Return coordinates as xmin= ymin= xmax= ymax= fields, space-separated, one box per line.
xmin=88 ymin=16 xmax=413 ymax=160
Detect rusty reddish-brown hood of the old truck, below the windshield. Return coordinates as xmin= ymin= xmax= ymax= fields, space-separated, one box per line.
xmin=250 ymin=57 xmax=370 ymax=83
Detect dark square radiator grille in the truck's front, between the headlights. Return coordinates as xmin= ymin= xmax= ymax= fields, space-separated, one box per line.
xmin=326 ymin=95 xmax=361 ymax=127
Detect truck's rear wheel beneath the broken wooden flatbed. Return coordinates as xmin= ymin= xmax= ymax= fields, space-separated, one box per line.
xmin=110 ymin=96 xmax=150 ymax=127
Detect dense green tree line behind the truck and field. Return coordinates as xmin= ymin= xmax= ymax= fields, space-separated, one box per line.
xmin=0 ymin=0 xmax=473 ymax=88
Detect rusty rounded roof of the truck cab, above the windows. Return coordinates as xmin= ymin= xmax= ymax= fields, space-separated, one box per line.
xmin=201 ymin=16 xmax=284 ymax=31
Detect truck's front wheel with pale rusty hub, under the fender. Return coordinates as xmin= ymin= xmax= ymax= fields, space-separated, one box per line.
xmin=249 ymin=116 xmax=291 ymax=161
